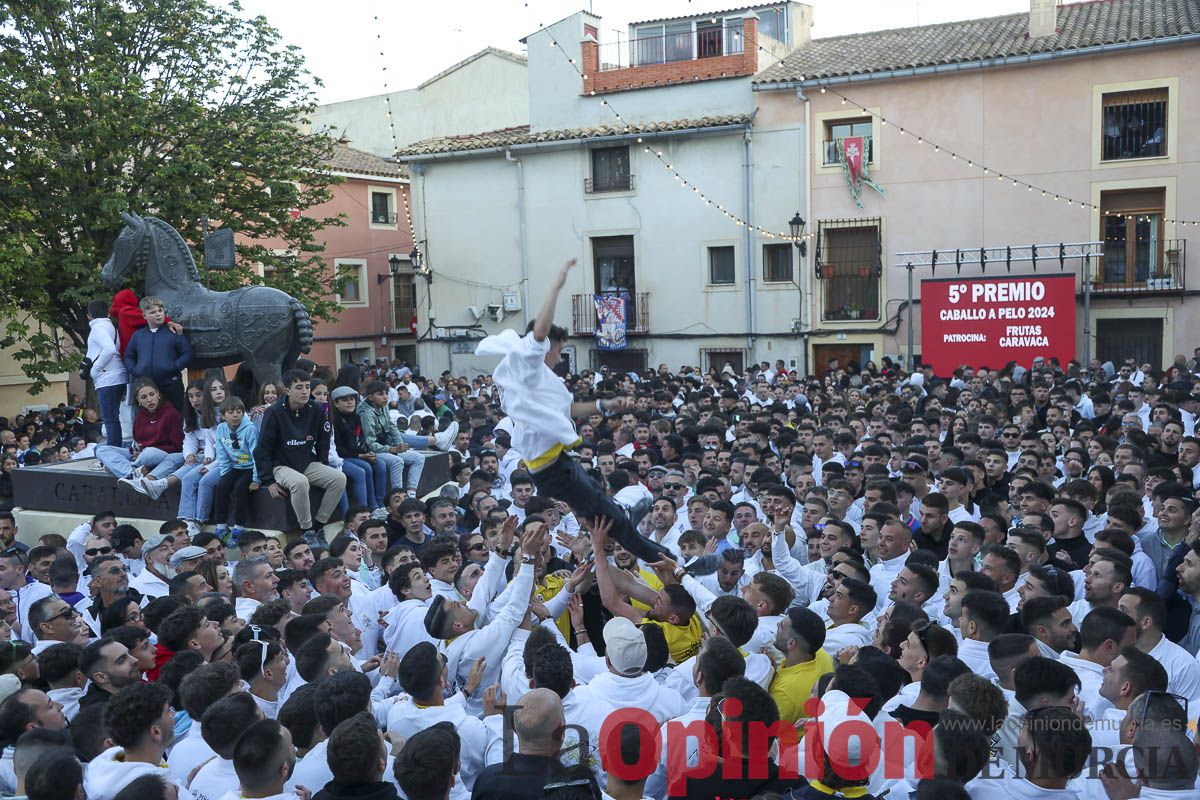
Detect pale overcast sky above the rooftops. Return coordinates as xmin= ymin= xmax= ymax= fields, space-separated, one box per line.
xmin=231 ymin=0 xmax=1030 ymax=103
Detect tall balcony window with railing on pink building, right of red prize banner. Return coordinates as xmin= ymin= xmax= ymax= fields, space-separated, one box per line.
xmin=1100 ymin=188 xmax=1174 ymax=288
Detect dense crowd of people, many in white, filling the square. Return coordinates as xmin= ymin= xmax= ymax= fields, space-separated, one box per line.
xmin=0 ymin=271 xmax=1200 ymax=800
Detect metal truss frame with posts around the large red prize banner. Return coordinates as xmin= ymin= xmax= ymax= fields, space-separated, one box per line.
xmin=895 ymin=241 xmax=1104 ymax=369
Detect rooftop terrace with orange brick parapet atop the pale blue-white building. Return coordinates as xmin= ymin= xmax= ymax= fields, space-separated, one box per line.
xmin=582 ymin=18 xmax=758 ymax=95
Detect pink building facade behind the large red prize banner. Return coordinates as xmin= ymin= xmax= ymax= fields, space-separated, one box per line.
xmin=754 ymin=0 xmax=1200 ymax=371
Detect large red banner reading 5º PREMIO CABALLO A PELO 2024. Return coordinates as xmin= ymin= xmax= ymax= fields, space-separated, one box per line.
xmin=920 ymin=275 xmax=1075 ymax=375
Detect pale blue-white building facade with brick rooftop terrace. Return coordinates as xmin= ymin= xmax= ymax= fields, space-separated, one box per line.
xmin=400 ymin=2 xmax=811 ymax=373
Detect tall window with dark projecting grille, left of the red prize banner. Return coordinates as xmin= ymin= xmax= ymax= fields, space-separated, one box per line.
xmin=817 ymin=219 xmax=883 ymax=320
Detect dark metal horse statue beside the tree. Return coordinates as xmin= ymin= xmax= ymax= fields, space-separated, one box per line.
xmin=100 ymin=212 xmax=312 ymax=386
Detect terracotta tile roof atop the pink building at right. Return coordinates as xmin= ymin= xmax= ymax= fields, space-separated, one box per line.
xmin=754 ymin=0 xmax=1200 ymax=84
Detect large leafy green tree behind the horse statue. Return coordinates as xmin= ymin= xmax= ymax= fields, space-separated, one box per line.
xmin=0 ymin=0 xmax=344 ymax=387
